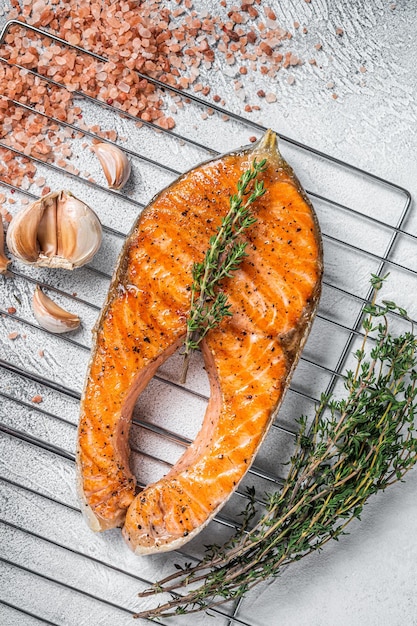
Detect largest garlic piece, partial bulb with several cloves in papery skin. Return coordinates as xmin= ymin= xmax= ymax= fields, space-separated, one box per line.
xmin=7 ymin=191 xmax=102 ymax=270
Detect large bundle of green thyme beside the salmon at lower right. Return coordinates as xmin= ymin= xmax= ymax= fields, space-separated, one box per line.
xmin=137 ymin=276 xmax=417 ymax=619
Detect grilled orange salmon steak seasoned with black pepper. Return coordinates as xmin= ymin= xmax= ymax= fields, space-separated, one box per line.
xmin=77 ymin=131 xmax=323 ymax=554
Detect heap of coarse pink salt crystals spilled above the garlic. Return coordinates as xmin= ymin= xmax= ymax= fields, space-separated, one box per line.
xmin=0 ymin=0 xmax=342 ymax=195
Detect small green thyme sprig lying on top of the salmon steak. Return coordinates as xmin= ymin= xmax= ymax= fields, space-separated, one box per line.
xmin=181 ymin=159 xmax=266 ymax=383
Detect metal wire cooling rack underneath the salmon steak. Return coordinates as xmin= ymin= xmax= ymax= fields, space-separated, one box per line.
xmin=0 ymin=21 xmax=417 ymax=626
